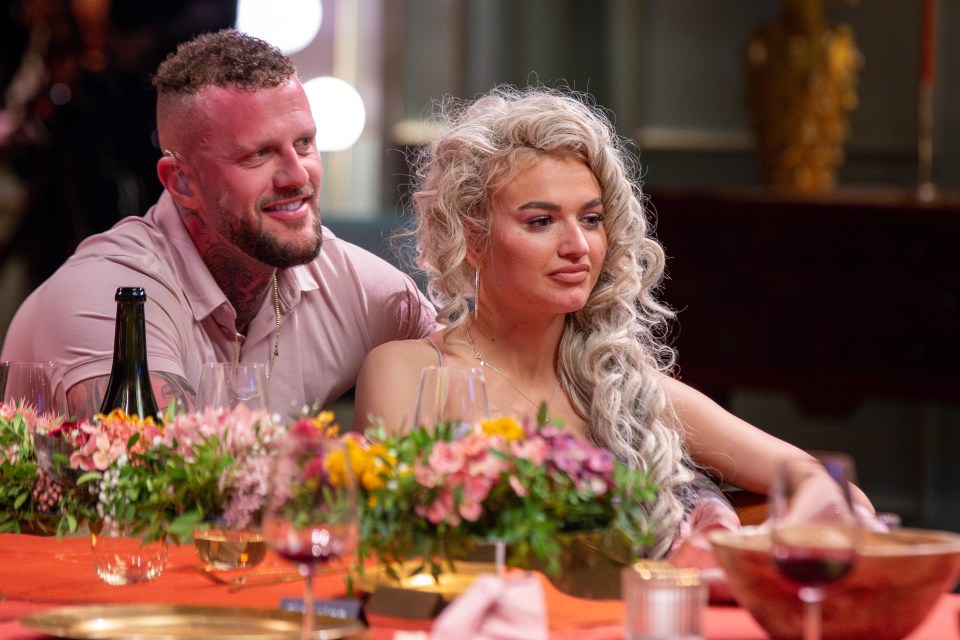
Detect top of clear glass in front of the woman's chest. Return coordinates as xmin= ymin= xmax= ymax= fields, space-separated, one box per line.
xmin=413 ymin=366 xmax=490 ymax=432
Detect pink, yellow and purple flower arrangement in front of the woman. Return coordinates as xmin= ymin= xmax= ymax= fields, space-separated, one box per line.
xmin=347 ymin=418 xmax=656 ymax=578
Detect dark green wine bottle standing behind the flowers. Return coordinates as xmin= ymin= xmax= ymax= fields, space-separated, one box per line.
xmin=100 ymin=287 xmax=159 ymax=420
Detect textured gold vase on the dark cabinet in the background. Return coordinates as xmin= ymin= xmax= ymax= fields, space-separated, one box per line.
xmin=747 ymin=0 xmax=862 ymax=193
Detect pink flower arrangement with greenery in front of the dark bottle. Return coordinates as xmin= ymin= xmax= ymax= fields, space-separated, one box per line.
xmin=0 ymin=405 xmax=284 ymax=542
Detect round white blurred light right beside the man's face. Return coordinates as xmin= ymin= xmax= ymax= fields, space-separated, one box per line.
xmin=303 ymin=76 xmax=367 ymax=151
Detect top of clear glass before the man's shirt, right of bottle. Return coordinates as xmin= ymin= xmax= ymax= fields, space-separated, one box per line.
xmin=196 ymin=362 xmax=270 ymax=411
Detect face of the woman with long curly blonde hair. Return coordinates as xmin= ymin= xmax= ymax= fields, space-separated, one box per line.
xmin=480 ymin=156 xmax=607 ymax=314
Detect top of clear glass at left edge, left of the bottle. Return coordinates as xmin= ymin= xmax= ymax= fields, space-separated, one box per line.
xmin=0 ymin=362 xmax=67 ymax=420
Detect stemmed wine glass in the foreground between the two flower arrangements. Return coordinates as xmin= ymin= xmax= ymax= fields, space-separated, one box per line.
xmin=262 ymin=425 xmax=359 ymax=640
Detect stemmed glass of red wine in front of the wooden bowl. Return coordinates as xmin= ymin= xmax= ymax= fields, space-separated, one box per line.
xmin=770 ymin=452 xmax=859 ymax=640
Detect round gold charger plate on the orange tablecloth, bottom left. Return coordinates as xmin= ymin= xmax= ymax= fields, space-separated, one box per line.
xmin=20 ymin=604 xmax=366 ymax=640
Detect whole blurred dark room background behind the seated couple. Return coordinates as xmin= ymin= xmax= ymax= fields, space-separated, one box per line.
xmin=0 ymin=0 xmax=960 ymax=529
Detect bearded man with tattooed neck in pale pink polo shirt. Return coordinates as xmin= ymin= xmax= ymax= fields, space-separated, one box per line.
xmin=2 ymin=29 xmax=435 ymax=417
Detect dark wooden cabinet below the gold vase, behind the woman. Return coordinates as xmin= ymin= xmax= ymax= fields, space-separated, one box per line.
xmin=651 ymin=189 xmax=960 ymax=413
